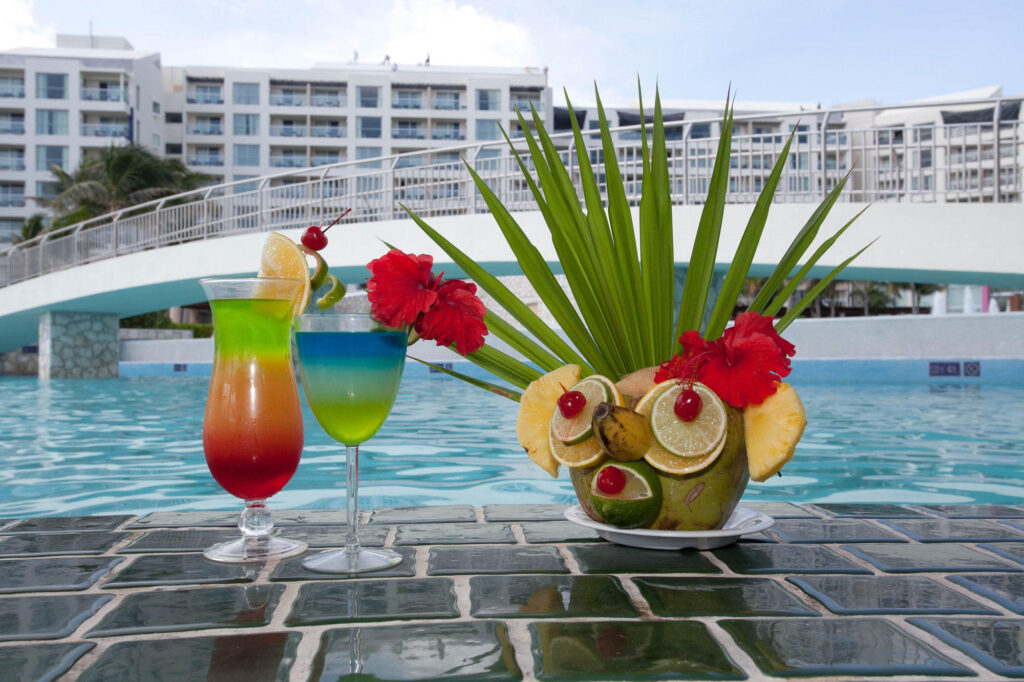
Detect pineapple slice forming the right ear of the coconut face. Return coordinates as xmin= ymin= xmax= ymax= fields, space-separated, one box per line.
xmin=743 ymin=383 xmax=807 ymax=481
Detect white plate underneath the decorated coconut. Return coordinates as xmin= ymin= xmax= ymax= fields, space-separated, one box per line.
xmin=565 ymin=505 xmax=775 ymax=550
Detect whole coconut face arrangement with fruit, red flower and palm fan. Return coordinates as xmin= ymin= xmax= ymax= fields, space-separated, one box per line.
xmin=392 ymin=84 xmax=866 ymax=530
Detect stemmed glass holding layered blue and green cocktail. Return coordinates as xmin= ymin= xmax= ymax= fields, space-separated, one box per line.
xmin=295 ymin=313 xmax=408 ymax=573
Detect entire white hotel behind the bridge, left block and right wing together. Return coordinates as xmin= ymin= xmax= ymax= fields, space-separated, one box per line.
xmin=0 ymin=36 xmax=1024 ymax=251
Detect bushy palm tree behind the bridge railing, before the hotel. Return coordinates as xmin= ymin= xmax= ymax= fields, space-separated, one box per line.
xmin=50 ymin=144 xmax=209 ymax=227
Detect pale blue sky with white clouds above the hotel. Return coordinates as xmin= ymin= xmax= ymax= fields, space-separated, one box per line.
xmin=0 ymin=0 xmax=1024 ymax=105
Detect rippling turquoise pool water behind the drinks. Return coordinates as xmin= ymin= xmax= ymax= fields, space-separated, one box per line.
xmin=0 ymin=367 xmax=1024 ymax=517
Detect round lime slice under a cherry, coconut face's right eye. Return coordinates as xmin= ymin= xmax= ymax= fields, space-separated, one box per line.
xmin=650 ymin=382 xmax=727 ymax=457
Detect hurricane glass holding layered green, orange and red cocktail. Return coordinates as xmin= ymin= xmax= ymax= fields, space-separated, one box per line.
xmin=201 ymin=278 xmax=306 ymax=562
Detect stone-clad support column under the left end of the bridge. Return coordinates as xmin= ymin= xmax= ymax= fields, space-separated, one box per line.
xmin=39 ymin=311 xmax=121 ymax=379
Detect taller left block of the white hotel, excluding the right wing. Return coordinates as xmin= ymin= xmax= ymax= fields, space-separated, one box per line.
xmin=0 ymin=36 xmax=551 ymax=250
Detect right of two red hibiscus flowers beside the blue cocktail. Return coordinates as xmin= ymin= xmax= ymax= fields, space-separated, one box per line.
xmin=416 ymin=280 xmax=487 ymax=355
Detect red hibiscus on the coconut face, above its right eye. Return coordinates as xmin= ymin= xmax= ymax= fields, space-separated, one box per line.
xmin=654 ymin=312 xmax=796 ymax=408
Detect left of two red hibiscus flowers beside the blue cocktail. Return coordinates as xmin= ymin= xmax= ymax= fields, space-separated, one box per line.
xmin=367 ymin=249 xmax=437 ymax=327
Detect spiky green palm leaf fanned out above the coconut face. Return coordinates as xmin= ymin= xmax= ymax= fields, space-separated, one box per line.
xmin=406 ymin=88 xmax=867 ymax=399
